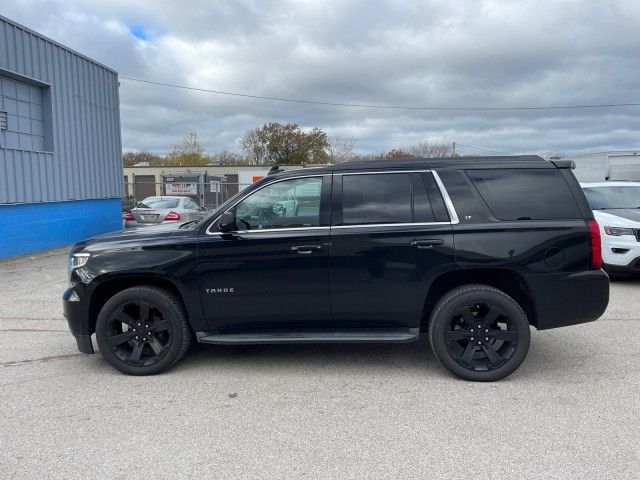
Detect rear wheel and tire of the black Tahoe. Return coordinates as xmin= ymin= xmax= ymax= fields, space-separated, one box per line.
xmin=428 ymin=284 xmax=531 ymax=382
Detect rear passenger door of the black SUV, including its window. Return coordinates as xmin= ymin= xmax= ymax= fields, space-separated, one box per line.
xmin=329 ymin=171 xmax=454 ymax=328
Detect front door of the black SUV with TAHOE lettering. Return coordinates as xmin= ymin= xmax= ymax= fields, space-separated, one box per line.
xmin=198 ymin=175 xmax=331 ymax=331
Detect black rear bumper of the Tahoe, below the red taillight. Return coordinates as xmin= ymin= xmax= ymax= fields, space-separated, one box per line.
xmin=527 ymin=270 xmax=609 ymax=330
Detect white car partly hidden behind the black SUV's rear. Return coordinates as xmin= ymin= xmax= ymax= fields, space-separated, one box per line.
xmin=581 ymin=182 xmax=640 ymax=274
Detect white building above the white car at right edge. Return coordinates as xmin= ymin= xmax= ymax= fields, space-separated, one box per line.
xmin=563 ymin=150 xmax=640 ymax=182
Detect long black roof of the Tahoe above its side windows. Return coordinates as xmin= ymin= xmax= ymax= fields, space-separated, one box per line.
xmin=272 ymin=155 xmax=564 ymax=176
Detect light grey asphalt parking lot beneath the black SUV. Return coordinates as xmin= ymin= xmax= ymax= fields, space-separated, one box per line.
xmin=0 ymin=250 xmax=640 ymax=479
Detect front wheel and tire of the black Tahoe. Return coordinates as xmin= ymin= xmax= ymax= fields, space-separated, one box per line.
xmin=96 ymin=286 xmax=191 ymax=375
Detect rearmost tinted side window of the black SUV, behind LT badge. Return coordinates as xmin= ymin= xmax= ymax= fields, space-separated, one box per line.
xmin=467 ymin=169 xmax=582 ymax=220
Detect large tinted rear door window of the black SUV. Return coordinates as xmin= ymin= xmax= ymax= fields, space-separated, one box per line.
xmin=342 ymin=173 xmax=412 ymax=225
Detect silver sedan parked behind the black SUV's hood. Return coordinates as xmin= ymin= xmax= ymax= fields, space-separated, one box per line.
xmin=125 ymin=195 xmax=207 ymax=227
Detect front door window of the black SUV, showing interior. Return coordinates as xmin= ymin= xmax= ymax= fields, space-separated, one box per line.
xmin=235 ymin=177 xmax=322 ymax=230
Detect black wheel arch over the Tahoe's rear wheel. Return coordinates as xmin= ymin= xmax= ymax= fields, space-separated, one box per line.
xmin=422 ymin=268 xmax=538 ymax=327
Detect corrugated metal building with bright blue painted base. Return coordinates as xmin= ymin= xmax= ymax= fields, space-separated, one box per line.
xmin=0 ymin=16 xmax=123 ymax=258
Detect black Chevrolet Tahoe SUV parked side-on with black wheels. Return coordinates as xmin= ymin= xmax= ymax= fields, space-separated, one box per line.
xmin=64 ymin=156 xmax=609 ymax=381
